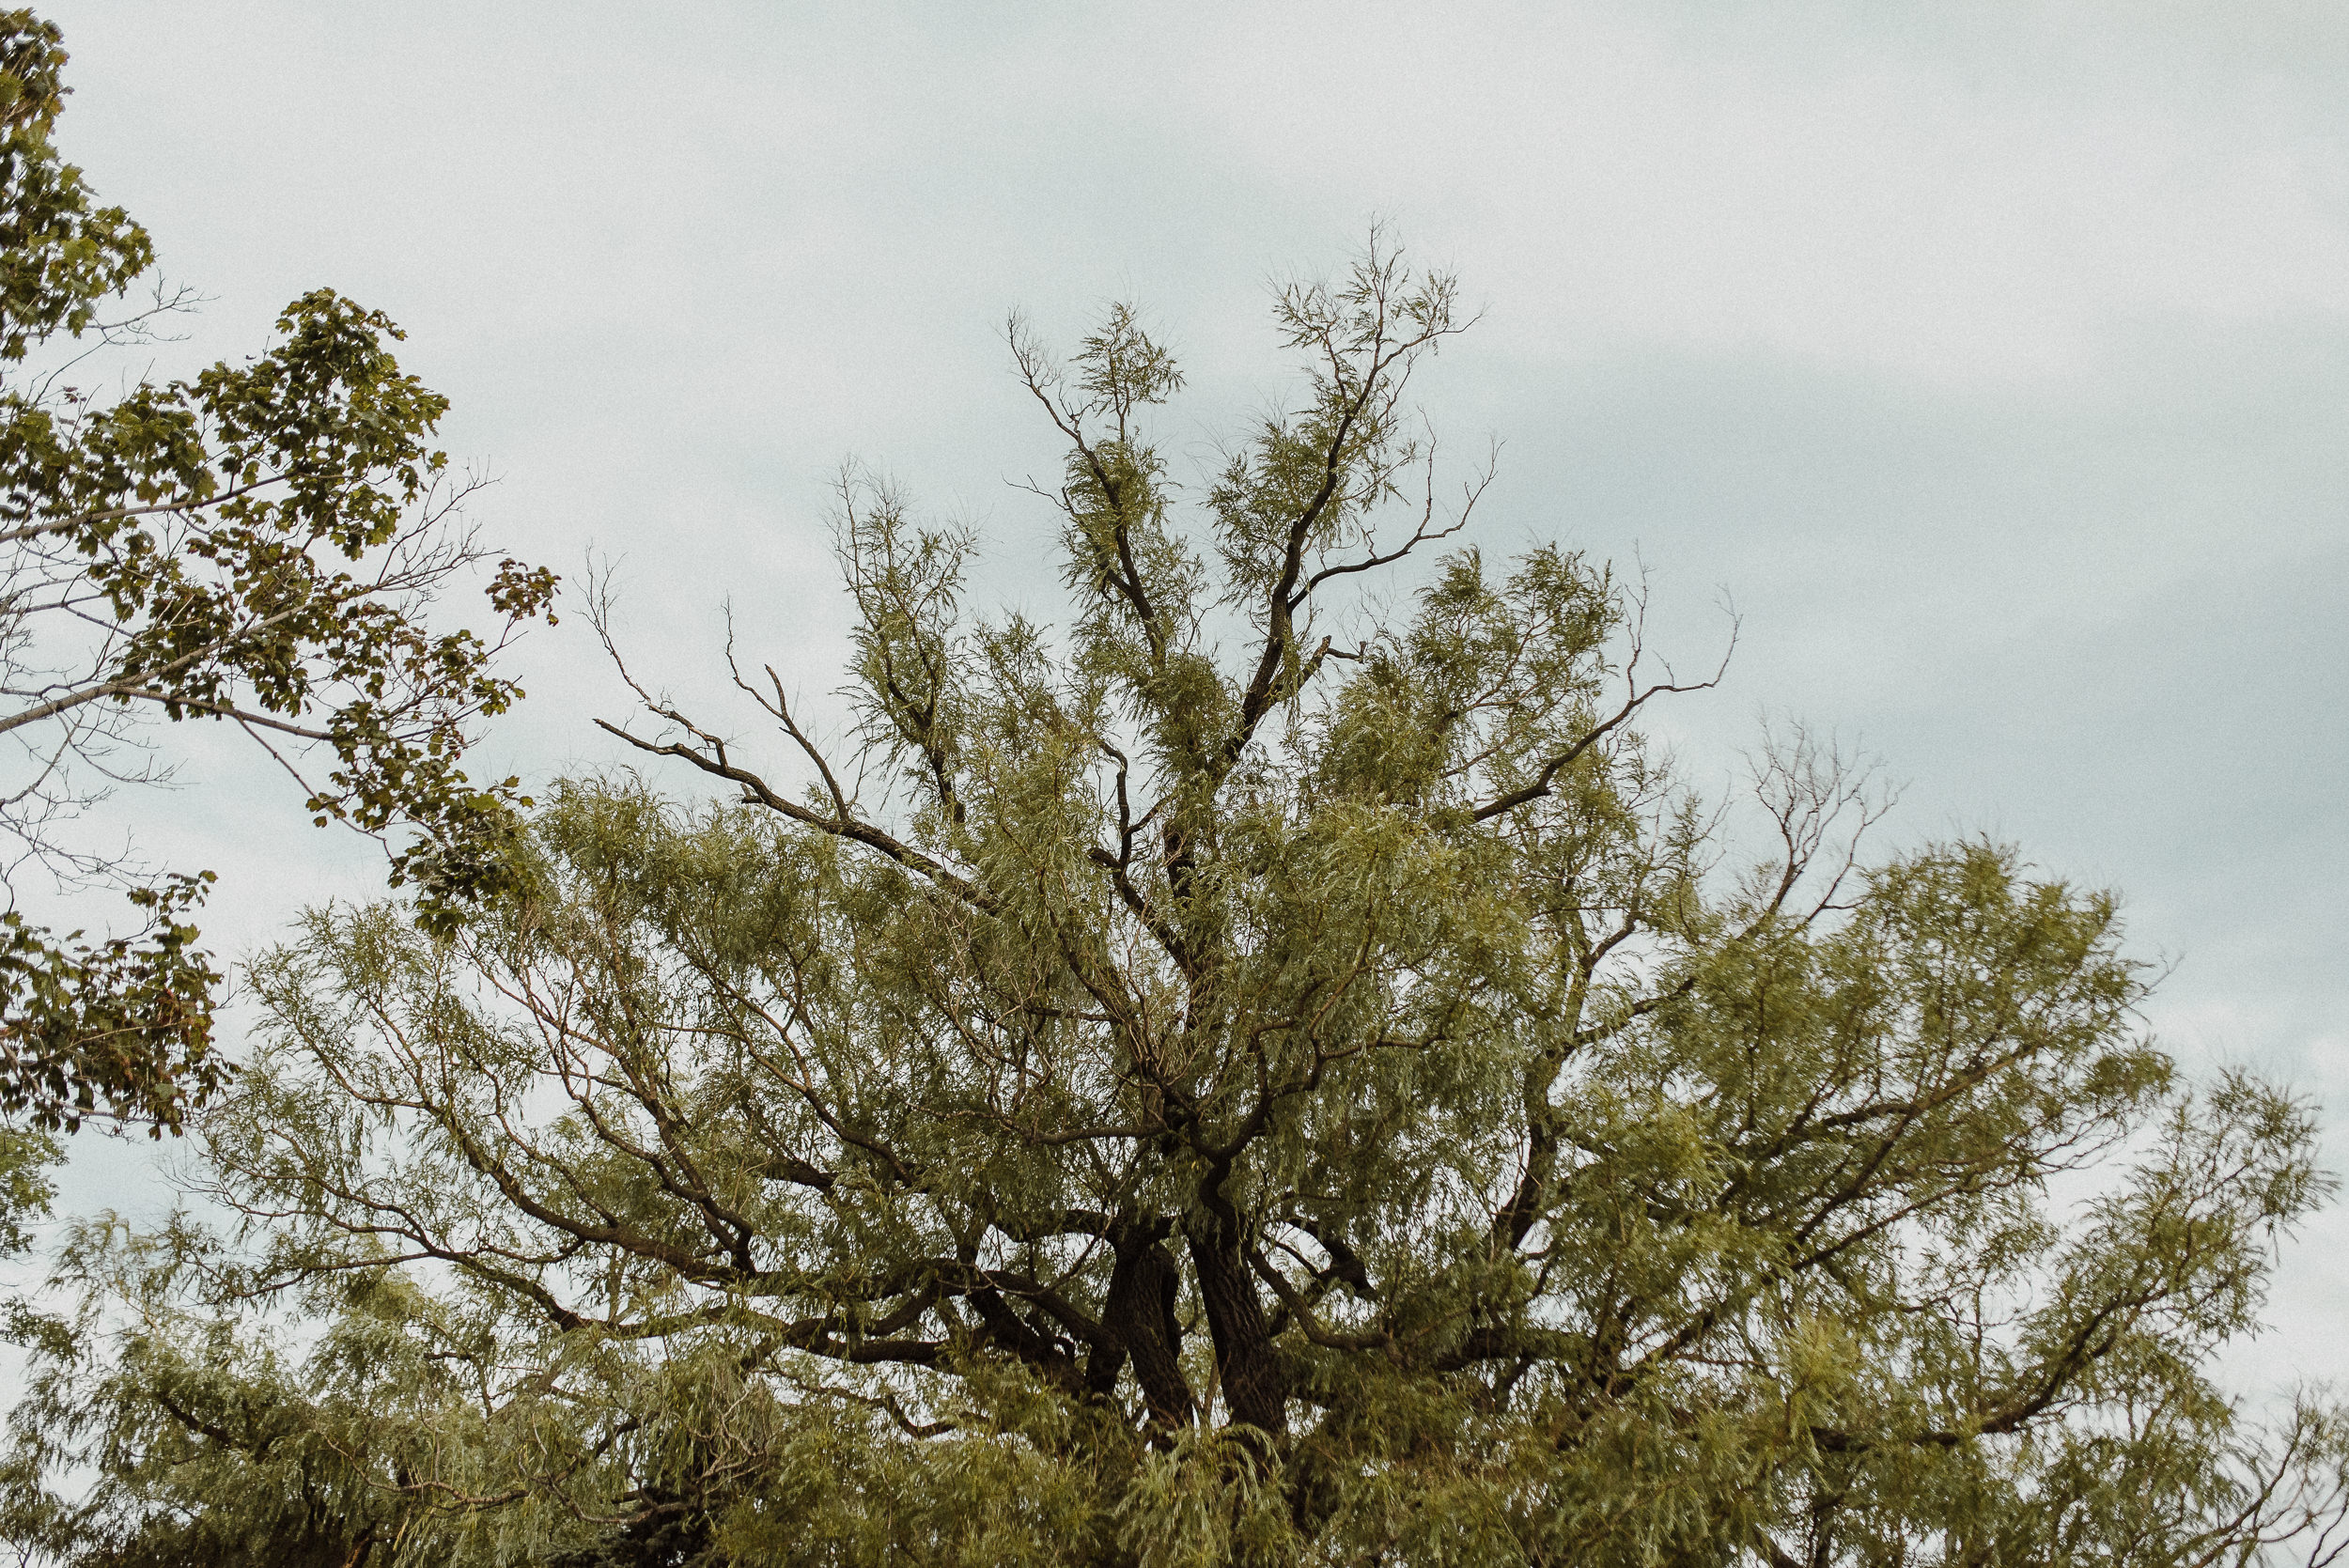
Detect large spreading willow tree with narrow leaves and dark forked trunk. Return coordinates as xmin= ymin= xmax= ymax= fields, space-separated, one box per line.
xmin=9 ymin=246 xmax=2349 ymax=1568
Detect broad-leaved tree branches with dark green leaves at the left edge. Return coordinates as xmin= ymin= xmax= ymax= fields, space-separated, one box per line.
xmin=0 ymin=9 xmax=554 ymax=1136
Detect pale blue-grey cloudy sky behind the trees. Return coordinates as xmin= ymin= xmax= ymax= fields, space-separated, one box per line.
xmin=18 ymin=0 xmax=2349 ymax=1385
